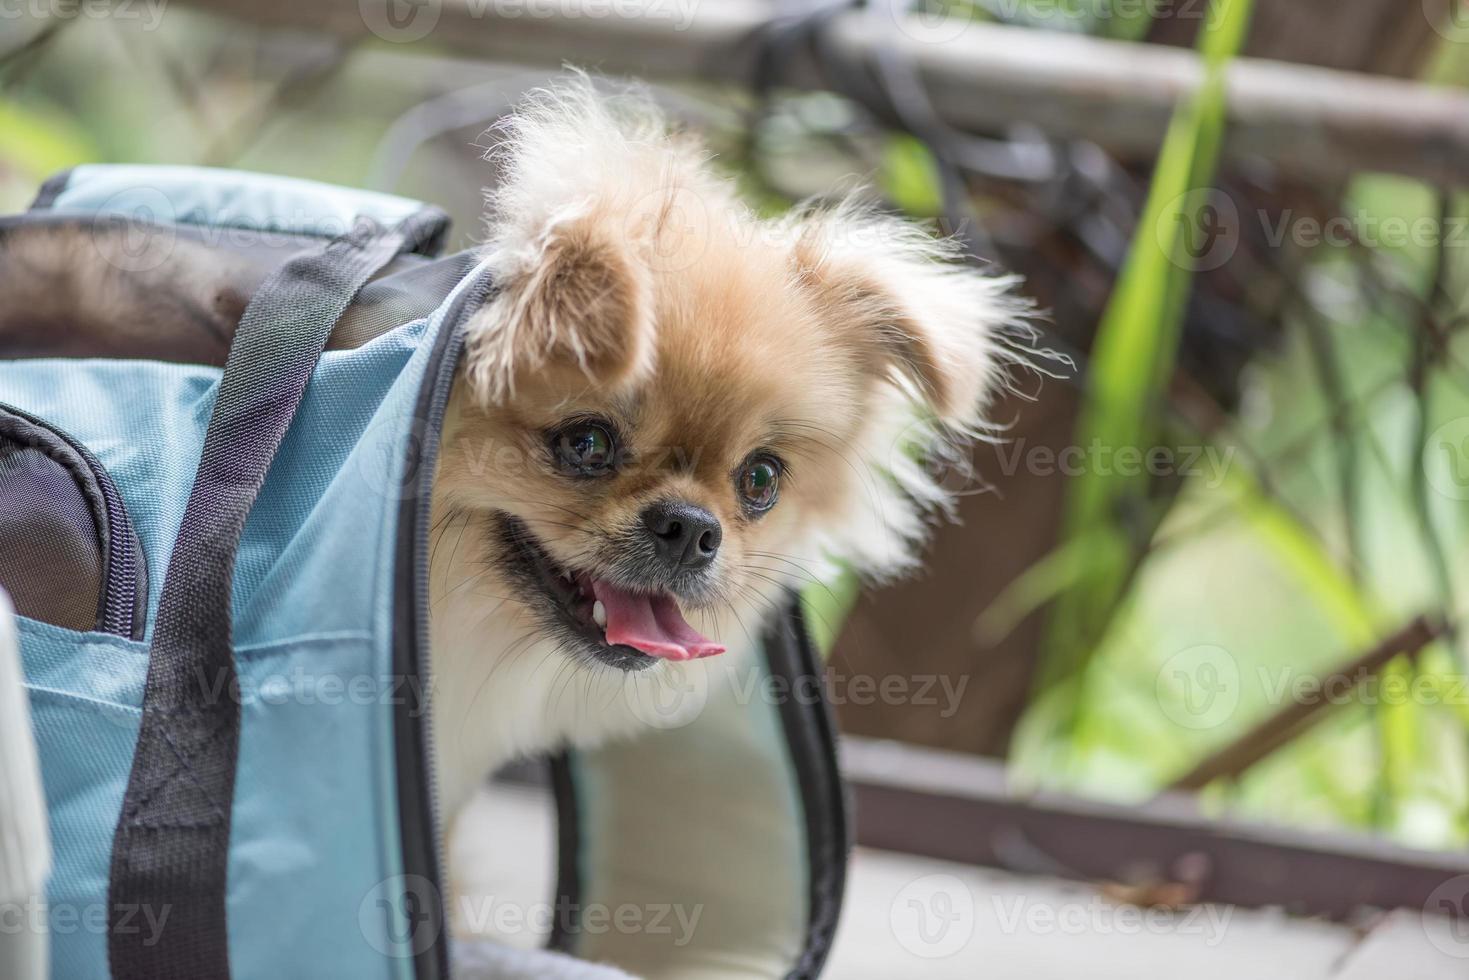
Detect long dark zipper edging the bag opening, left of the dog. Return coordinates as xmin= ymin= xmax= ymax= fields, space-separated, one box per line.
xmin=394 ymin=271 xmax=489 ymax=980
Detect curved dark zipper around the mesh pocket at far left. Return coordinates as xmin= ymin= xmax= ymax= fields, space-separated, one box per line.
xmin=0 ymin=403 xmax=148 ymax=639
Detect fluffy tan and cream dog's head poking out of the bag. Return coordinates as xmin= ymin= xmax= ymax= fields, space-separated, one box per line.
xmin=441 ymin=82 xmax=1022 ymax=670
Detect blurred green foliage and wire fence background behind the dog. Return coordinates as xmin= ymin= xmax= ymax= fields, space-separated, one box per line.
xmin=0 ymin=0 xmax=1469 ymax=963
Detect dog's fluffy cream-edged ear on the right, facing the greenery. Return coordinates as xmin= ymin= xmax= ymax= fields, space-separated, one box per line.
xmin=793 ymin=207 xmax=1028 ymax=429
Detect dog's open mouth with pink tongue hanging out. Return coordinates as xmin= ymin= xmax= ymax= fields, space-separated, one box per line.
xmin=504 ymin=516 xmax=724 ymax=670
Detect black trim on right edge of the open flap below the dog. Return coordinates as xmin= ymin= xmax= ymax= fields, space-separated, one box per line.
xmin=765 ymin=597 xmax=852 ymax=980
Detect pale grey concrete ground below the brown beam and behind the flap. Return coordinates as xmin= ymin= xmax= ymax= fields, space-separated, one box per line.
xmin=450 ymin=785 xmax=1469 ymax=980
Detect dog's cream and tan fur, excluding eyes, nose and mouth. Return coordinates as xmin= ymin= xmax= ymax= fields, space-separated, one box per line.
xmin=430 ymin=76 xmax=1027 ymax=975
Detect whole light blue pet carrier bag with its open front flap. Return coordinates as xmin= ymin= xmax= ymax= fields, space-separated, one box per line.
xmin=0 ymin=166 xmax=846 ymax=980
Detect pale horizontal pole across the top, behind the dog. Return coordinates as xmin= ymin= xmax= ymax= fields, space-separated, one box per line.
xmin=166 ymin=0 xmax=1469 ymax=185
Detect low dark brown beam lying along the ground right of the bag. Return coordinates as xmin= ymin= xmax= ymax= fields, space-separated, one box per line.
xmin=842 ymin=739 xmax=1469 ymax=921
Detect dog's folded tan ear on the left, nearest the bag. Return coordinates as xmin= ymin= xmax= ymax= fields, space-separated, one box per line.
xmin=464 ymin=212 xmax=654 ymax=404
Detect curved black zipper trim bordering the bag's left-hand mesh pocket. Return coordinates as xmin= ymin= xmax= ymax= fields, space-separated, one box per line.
xmin=0 ymin=403 xmax=148 ymax=639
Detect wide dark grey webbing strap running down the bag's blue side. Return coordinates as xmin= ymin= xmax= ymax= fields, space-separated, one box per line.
xmin=107 ymin=210 xmax=447 ymax=980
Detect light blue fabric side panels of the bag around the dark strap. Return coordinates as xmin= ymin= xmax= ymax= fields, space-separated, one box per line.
xmin=0 ymin=221 xmax=473 ymax=980
